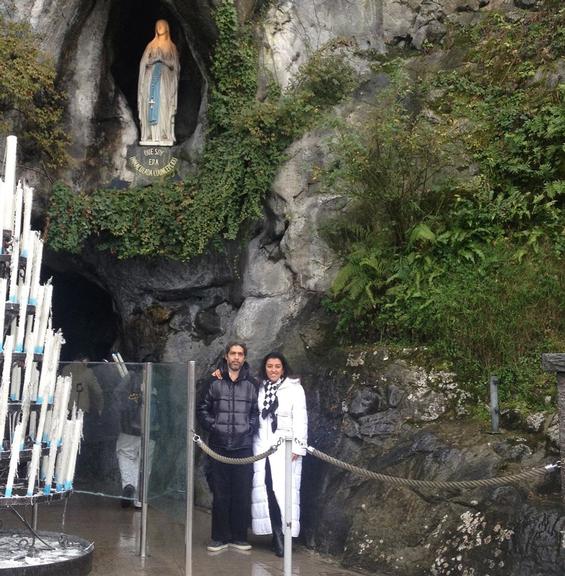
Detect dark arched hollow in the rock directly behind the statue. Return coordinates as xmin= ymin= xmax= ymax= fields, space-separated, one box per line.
xmin=108 ymin=0 xmax=203 ymax=144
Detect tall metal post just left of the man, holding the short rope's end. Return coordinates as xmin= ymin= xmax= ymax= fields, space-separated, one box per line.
xmin=184 ymin=360 xmax=196 ymax=576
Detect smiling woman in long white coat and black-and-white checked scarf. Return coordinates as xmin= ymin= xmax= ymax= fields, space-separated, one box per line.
xmin=251 ymin=352 xmax=308 ymax=557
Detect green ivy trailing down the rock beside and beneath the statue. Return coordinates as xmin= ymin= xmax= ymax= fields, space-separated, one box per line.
xmin=49 ymin=0 xmax=354 ymax=260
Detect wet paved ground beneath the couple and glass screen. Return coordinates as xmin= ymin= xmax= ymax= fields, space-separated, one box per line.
xmin=10 ymin=494 xmax=366 ymax=576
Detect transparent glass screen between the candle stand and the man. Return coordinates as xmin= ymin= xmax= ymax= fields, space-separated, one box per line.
xmin=59 ymin=362 xmax=192 ymax=566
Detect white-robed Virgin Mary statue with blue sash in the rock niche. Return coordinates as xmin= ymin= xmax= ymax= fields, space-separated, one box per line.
xmin=137 ymin=20 xmax=180 ymax=146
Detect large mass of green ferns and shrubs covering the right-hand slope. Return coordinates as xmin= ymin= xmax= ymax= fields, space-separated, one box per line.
xmin=326 ymin=8 xmax=565 ymax=407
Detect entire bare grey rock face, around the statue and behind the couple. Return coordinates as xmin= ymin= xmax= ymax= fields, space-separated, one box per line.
xmin=7 ymin=0 xmax=565 ymax=576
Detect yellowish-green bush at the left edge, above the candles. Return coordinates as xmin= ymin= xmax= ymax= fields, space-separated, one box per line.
xmin=0 ymin=14 xmax=67 ymax=168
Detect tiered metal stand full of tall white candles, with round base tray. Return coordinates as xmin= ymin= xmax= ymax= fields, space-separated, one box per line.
xmin=0 ymin=136 xmax=94 ymax=576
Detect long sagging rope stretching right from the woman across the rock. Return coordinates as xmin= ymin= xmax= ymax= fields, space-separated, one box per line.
xmin=304 ymin=446 xmax=560 ymax=488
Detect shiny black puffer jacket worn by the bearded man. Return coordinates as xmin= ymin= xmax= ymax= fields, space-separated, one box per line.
xmin=197 ymin=363 xmax=259 ymax=450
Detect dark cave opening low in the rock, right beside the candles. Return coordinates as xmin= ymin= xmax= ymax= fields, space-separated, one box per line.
xmin=43 ymin=268 xmax=118 ymax=362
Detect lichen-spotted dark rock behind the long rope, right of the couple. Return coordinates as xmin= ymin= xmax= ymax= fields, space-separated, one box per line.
xmin=302 ymin=349 xmax=565 ymax=576
